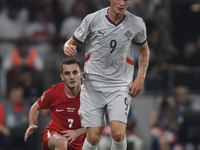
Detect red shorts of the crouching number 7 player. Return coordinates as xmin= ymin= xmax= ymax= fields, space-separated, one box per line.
xmin=41 ymin=128 xmax=86 ymax=150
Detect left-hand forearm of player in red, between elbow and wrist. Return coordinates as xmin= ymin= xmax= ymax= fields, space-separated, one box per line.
xmin=29 ymin=102 xmax=40 ymax=126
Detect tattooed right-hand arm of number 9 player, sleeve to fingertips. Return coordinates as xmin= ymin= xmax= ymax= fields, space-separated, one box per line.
xmin=130 ymin=42 xmax=149 ymax=97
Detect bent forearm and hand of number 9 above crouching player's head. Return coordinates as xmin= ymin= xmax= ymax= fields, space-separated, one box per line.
xmin=63 ymin=38 xmax=79 ymax=56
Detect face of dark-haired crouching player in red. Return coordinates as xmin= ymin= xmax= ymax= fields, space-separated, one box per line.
xmin=61 ymin=64 xmax=83 ymax=88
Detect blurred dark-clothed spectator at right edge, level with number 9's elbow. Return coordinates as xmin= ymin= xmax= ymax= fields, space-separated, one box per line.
xmin=162 ymin=42 xmax=200 ymax=90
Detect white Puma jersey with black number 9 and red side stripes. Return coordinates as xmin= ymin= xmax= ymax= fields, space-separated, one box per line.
xmin=73 ymin=8 xmax=146 ymax=91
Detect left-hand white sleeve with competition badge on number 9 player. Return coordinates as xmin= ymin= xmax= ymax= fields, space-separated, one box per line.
xmin=73 ymin=15 xmax=91 ymax=44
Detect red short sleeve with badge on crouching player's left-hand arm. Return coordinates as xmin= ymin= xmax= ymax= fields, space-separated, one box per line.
xmin=38 ymin=89 xmax=52 ymax=109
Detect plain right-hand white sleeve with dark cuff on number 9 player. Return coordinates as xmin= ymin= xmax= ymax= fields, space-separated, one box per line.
xmin=133 ymin=18 xmax=147 ymax=45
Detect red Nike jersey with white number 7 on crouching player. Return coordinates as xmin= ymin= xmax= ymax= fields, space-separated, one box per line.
xmin=38 ymin=82 xmax=85 ymax=149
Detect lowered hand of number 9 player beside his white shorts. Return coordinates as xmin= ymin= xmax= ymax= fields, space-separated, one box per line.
xmin=130 ymin=77 xmax=144 ymax=97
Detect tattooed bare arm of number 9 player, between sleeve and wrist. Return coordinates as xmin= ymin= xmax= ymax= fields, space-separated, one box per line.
xmin=138 ymin=43 xmax=149 ymax=78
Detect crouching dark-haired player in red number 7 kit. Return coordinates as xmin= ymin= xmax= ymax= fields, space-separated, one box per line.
xmin=24 ymin=58 xmax=86 ymax=150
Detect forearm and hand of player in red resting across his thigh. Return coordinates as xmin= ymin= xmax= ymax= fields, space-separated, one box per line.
xmin=61 ymin=128 xmax=87 ymax=144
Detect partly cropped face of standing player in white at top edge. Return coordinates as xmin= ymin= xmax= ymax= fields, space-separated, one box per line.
xmin=110 ymin=0 xmax=131 ymax=15
